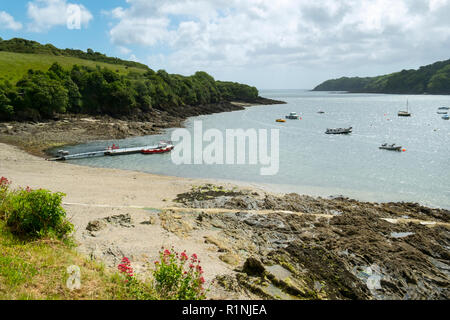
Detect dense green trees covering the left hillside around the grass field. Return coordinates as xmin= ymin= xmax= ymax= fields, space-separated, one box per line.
xmin=0 ymin=39 xmax=258 ymax=121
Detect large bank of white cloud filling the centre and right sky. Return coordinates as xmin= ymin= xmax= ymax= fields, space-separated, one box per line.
xmin=109 ymin=0 xmax=450 ymax=87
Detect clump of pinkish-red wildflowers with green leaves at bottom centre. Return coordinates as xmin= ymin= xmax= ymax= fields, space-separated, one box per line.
xmin=153 ymin=248 xmax=206 ymax=300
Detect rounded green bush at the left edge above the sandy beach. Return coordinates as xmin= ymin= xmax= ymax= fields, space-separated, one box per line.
xmin=1 ymin=188 xmax=73 ymax=239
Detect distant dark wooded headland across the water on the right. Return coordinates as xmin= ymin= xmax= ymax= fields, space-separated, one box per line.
xmin=314 ymin=60 xmax=450 ymax=94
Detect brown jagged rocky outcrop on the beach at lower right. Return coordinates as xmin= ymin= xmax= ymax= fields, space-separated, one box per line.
xmin=171 ymin=186 xmax=450 ymax=300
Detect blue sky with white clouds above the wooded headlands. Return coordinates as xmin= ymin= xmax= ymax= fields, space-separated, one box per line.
xmin=0 ymin=0 xmax=450 ymax=89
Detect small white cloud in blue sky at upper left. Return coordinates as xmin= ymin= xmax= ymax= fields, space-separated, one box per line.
xmin=27 ymin=0 xmax=93 ymax=32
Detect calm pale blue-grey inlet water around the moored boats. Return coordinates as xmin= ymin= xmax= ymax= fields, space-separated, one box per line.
xmin=60 ymin=90 xmax=450 ymax=208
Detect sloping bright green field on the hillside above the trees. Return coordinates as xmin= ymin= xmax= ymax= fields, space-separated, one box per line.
xmin=0 ymin=51 xmax=146 ymax=84
